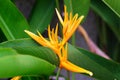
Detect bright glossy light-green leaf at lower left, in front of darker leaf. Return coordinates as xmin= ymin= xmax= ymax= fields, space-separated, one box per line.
xmin=0 ymin=55 xmax=55 ymax=78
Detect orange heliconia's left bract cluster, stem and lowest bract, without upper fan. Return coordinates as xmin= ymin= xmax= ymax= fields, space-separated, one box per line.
xmin=25 ymin=27 xmax=93 ymax=76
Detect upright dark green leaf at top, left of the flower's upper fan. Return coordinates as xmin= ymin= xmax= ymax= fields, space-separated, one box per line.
xmin=29 ymin=0 xmax=55 ymax=33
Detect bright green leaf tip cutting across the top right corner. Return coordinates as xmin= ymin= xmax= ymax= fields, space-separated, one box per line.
xmin=102 ymin=0 xmax=120 ymax=17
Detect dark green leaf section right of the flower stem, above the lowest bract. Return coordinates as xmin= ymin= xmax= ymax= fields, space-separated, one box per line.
xmin=68 ymin=45 xmax=120 ymax=80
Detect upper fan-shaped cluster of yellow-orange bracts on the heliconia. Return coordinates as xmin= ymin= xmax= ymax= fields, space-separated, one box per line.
xmin=56 ymin=6 xmax=84 ymax=44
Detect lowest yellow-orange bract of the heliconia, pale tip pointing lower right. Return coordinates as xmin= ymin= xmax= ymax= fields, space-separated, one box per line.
xmin=60 ymin=61 xmax=93 ymax=76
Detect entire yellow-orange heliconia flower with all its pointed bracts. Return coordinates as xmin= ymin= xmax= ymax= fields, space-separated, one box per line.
xmin=25 ymin=4 xmax=93 ymax=76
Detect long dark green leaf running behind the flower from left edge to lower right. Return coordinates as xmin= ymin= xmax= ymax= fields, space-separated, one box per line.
xmin=0 ymin=39 xmax=120 ymax=80
